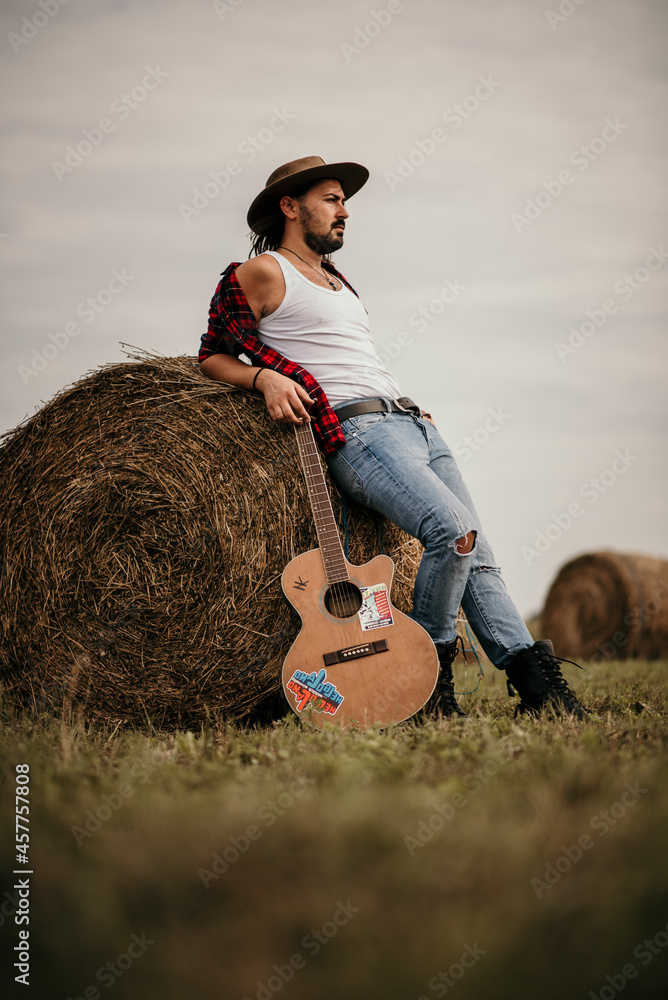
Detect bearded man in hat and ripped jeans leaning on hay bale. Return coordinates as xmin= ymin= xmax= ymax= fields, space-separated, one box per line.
xmin=199 ymin=156 xmax=586 ymax=718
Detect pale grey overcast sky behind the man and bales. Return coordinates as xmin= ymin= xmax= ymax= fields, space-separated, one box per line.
xmin=0 ymin=0 xmax=668 ymax=614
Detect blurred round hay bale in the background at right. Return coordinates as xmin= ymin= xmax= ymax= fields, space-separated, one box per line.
xmin=543 ymin=552 xmax=668 ymax=662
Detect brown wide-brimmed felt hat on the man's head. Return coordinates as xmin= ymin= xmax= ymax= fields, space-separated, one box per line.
xmin=247 ymin=156 xmax=369 ymax=236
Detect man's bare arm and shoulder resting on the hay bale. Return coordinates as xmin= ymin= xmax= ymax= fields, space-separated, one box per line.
xmin=200 ymin=257 xmax=313 ymax=424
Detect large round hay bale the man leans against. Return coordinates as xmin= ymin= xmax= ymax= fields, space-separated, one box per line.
xmin=0 ymin=355 xmax=421 ymax=726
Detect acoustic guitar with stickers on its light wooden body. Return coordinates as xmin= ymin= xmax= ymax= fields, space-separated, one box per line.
xmin=281 ymin=423 xmax=439 ymax=729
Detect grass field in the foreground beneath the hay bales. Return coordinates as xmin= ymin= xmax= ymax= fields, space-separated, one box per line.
xmin=0 ymin=662 xmax=668 ymax=1000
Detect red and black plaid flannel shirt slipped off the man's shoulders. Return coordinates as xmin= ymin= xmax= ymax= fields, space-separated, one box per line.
xmin=197 ymin=261 xmax=357 ymax=455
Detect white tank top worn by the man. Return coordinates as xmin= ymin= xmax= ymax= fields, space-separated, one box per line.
xmin=258 ymin=250 xmax=401 ymax=406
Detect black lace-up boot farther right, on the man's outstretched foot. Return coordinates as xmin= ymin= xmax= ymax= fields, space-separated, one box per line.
xmin=506 ymin=639 xmax=589 ymax=719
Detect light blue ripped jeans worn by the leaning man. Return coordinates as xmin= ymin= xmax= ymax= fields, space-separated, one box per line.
xmin=327 ymin=400 xmax=533 ymax=669
